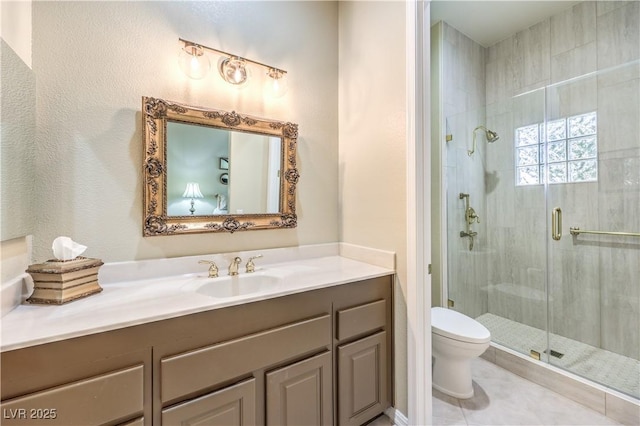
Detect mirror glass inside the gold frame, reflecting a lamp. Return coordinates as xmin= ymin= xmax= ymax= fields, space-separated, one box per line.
xmin=166 ymin=120 xmax=282 ymax=216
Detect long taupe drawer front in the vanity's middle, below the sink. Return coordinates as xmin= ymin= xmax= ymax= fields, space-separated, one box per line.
xmin=160 ymin=314 xmax=331 ymax=403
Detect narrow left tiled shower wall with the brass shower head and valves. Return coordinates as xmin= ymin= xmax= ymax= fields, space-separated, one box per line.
xmin=438 ymin=23 xmax=489 ymax=317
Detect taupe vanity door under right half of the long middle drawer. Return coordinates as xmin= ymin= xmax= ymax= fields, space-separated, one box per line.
xmin=266 ymin=352 xmax=333 ymax=426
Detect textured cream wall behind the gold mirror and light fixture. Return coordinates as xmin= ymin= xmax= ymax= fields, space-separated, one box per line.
xmin=33 ymin=1 xmax=338 ymax=261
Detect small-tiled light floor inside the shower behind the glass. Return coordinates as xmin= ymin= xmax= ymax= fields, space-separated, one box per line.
xmin=476 ymin=313 xmax=640 ymax=398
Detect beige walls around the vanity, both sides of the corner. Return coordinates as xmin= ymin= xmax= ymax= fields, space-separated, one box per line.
xmin=3 ymin=1 xmax=407 ymax=413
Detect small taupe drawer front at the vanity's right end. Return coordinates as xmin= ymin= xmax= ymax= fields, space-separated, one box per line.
xmin=336 ymin=300 xmax=387 ymax=340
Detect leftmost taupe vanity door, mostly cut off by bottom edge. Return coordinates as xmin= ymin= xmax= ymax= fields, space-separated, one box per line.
xmin=162 ymin=379 xmax=256 ymax=426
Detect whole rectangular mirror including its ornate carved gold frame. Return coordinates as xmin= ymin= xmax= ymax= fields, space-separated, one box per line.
xmin=142 ymin=97 xmax=299 ymax=236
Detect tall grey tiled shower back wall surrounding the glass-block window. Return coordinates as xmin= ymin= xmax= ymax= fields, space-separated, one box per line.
xmin=484 ymin=1 xmax=640 ymax=359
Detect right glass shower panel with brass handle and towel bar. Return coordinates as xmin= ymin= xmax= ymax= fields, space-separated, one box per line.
xmin=544 ymin=62 xmax=640 ymax=398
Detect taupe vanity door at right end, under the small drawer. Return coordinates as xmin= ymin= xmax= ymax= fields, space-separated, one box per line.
xmin=338 ymin=331 xmax=389 ymax=425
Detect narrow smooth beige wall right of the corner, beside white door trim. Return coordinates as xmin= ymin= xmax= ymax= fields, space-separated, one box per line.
xmin=339 ymin=1 xmax=407 ymax=413
